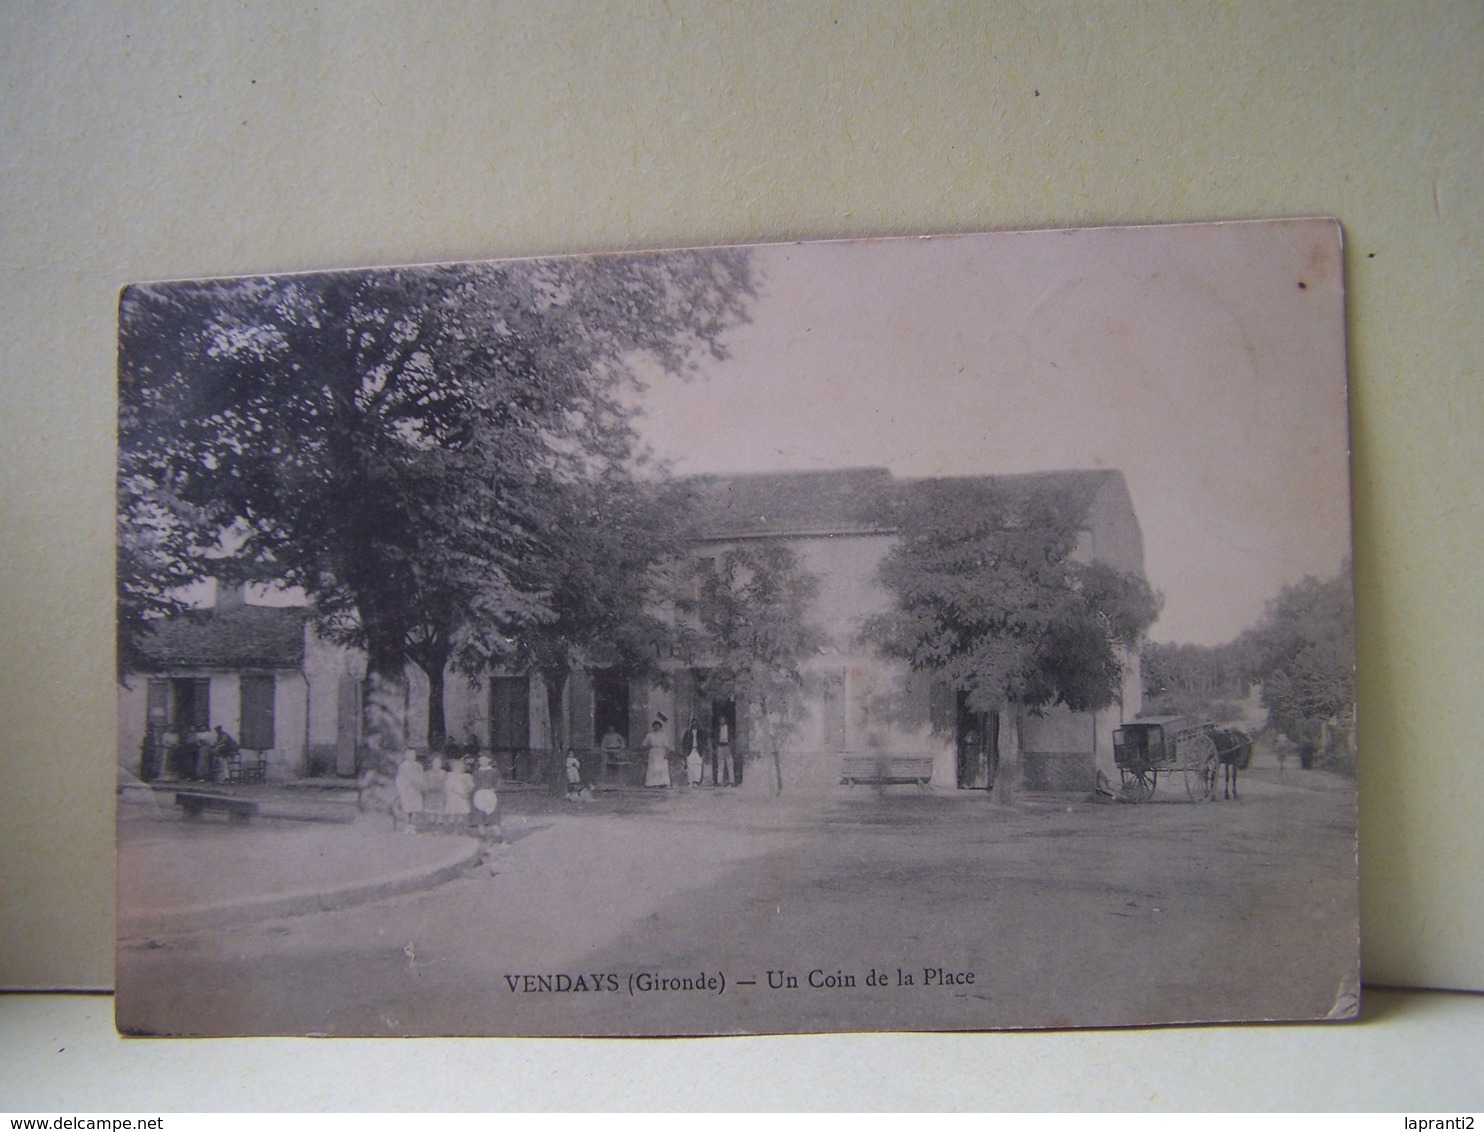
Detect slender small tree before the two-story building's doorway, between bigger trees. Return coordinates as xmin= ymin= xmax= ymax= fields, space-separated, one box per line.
xmin=680 ymin=540 xmax=828 ymax=794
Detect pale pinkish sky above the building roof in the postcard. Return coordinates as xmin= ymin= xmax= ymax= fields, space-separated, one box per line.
xmin=641 ymin=221 xmax=1350 ymax=644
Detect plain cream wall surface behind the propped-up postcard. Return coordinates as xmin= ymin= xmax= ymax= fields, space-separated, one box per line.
xmin=0 ymin=0 xmax=1484 ymax=1080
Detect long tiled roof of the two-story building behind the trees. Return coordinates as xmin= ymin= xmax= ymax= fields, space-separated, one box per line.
xmin=686 ymin=467 xmax=1120 ymax=539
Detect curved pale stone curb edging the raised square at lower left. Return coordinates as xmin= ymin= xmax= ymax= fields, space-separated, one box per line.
xmin=117 ymin=838 xmax=482 ymax=941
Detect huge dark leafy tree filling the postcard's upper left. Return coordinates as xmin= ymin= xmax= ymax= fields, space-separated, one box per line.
xmin=119 ymin=251 xmax=754 ymax=756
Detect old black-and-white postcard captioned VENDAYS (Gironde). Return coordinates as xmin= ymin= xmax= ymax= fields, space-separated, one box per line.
xmin=117 ymin=220 xmax=1359 ymax=1036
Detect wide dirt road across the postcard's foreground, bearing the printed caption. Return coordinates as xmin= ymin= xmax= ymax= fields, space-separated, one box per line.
xmin=119 ymin=770 xmax=1358 ymax=1036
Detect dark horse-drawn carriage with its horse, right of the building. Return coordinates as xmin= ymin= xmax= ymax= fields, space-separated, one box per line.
xmin=1113 ymin=715 xmax=1252 ymax=801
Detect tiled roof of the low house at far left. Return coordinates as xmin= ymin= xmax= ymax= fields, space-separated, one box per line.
xmin=141 ymin=605 xmax=309 ymax=668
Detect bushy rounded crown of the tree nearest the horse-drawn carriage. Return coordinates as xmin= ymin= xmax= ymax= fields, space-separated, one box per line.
xmin=865 ymin=479 xmax=1159 ymax=711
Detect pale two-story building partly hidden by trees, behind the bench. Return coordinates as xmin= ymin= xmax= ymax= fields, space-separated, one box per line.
xmin=647 ymin=467 xmax=1144 ymax=791
